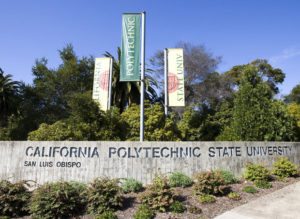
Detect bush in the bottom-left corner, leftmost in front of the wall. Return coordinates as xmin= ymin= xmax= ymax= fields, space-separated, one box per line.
xmin=0 ymin=180 xmax=31 ymax=217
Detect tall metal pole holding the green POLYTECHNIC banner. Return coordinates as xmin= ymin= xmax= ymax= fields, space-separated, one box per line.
xmin=140 ymin=12 xmax=146 ymax=142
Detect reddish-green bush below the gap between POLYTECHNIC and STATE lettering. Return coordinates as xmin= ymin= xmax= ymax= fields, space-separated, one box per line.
xmin=193 ymin=171 xmax=230 ymax=195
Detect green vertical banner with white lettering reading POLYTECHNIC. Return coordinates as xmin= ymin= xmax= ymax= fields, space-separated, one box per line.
xmin=120 ymin=14 xmax=141 ymax=81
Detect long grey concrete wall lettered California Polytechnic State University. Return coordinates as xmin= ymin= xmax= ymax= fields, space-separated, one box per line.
xmin=0 ymin=141 xmax=300 ymax=184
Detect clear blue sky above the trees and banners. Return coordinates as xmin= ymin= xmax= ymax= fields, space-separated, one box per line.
xmin=0 ymin=0 xmax=300 ymax=94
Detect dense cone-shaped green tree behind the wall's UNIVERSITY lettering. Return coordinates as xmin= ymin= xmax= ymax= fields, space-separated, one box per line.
xmin=218 ymin=65 xmax=295 ymax=141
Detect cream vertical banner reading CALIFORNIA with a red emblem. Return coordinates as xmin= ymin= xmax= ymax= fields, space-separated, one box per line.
xmin=93 ymin=58 xmax=112 ymax=111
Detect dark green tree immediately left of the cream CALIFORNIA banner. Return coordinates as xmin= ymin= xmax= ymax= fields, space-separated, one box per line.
xmin=32 ymin=45 xmax=94 ymax=124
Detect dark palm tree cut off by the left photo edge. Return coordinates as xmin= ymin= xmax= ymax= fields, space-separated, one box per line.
xmin=0 ymin=68 xmax=20 ymax=126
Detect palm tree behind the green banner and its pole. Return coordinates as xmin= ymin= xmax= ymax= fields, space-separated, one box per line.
xmin=104 ymin=47 xmax=157 ymax=112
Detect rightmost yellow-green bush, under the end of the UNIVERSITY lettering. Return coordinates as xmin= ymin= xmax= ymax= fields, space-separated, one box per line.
xmin=272 ymin=157 xmax=298 ymax=178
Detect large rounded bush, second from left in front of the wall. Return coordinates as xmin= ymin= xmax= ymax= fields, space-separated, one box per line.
xmin=30 ymin=182 xmax=87 ymax=218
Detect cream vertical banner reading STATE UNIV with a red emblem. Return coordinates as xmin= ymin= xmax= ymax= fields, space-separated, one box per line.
xmin=167 ymin=49 xmax=185 ymax=106
